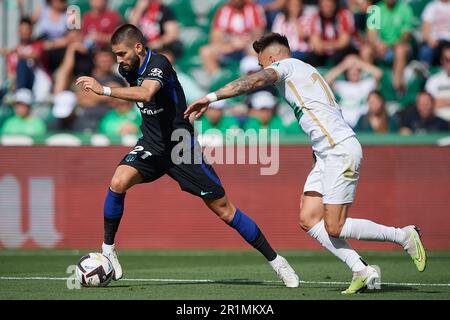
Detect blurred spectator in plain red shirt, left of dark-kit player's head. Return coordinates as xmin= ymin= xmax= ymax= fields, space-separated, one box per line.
xmin=81 ymin=0 xmax=120 ymax=48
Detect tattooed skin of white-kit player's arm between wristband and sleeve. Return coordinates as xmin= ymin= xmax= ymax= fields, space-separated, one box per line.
xmin=215 ymin=68 xmax=278 ymax=100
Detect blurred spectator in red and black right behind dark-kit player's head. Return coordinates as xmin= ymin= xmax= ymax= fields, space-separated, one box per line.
xmin=128 ymin=0 xmax=182 ymax=57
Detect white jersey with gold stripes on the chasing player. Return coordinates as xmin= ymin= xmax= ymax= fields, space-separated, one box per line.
xmin=267 ymin=58 xmax=355 ymax=152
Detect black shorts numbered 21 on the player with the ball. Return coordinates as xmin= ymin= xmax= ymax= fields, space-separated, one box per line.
xmin=119 ymin=139 xmax=225 ymax=199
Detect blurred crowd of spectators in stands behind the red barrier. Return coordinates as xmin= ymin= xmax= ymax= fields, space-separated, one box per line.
xmin=0 ymin=0 xmax=450 ymax=141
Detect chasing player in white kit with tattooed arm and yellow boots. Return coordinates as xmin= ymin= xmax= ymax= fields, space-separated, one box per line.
xmin=185 ymin=33 xmax=426 ymax=294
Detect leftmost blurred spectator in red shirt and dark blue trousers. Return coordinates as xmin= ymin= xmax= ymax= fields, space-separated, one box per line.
xmin=0 ymin=17 xmax=45 ymax=90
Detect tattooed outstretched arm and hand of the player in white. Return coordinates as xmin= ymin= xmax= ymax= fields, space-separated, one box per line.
xmin=184 ymin=68 xmax=278 ymax=120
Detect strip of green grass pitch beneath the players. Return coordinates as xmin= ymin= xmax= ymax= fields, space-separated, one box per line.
xmin=0 ymin=250 xmax=450 ymax=300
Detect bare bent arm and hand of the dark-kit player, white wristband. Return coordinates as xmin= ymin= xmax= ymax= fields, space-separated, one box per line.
xmin=76 ymin=77 xmax=161 ymax=102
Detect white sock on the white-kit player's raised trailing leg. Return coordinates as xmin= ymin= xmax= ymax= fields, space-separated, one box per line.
xmin=339 ymin=218 xmax=407 ymax=246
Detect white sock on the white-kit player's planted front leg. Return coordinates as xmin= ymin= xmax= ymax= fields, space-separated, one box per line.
xmin=307 ymin=219 xmax=366 ymax=272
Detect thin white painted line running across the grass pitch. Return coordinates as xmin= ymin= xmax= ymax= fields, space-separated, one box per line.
xmin=0 ymin=277 xmax=450 ymax=287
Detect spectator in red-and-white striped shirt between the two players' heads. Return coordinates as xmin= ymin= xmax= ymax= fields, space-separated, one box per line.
xmin=200 ymin=0 xmax=266 ymax=74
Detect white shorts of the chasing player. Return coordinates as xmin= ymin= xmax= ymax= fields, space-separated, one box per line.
xmin=303 ymin=136 xmax=362 ymax=204
